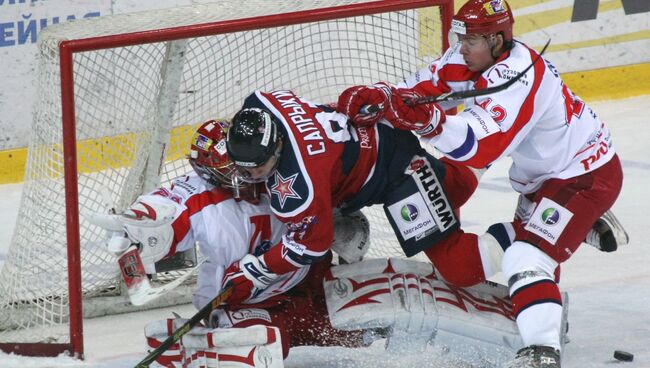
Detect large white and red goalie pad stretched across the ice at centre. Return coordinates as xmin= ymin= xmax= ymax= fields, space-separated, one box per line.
xmin=324 ymin=259 xmax=536 ymax=366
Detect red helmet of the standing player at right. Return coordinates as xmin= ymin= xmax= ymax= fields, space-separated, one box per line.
xmin=451 ymin=0 xmax=515 ymax=41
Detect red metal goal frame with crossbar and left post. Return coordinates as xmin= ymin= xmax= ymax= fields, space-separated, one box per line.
xmin=0 ymin=0 xmax=454 ymax=359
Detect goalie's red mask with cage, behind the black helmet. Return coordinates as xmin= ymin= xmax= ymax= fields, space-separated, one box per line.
xmin=188 ymin=120 xmax=259 ymax=202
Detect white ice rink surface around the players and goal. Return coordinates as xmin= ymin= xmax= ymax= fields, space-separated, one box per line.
xmin=0 ymin=96 xmax=650 ymax=368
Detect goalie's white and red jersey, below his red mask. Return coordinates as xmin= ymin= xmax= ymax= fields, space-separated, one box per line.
xmin=140 ymin=174 xmax=309 ymax=308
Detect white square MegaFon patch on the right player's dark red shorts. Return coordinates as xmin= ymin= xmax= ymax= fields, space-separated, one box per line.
xmin=524 ymin=198 xmax=573 ymax=245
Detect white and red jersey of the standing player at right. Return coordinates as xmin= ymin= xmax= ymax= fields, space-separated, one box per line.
xmin=398 ymin=42 xmax=614 ymax=194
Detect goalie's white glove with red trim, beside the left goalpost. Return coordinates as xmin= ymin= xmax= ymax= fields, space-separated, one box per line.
xmin=83 ymin=195 xmax=176 ymax=274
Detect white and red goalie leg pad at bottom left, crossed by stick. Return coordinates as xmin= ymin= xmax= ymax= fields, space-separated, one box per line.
xmin=145 ymin=318 xmax=284 ymax=368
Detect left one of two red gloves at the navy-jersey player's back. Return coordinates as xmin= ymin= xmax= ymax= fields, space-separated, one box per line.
xmin=336 ymin=82 xmax=390 ymax=127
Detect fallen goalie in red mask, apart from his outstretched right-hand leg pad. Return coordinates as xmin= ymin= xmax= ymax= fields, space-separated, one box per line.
xmin=86 ymin=120 xmax=368 ymax=367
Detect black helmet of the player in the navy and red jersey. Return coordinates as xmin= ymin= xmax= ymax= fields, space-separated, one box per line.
xmin=226 ymin=108 xmax=281 ymax=168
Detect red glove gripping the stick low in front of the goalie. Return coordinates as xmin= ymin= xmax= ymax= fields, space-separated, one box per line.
xmin=221 ymin=254 xmax=278 ymax=305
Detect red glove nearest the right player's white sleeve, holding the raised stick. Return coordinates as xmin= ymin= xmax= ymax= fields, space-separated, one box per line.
xmin=385 ymin=88 xmax=447 ymax=138
